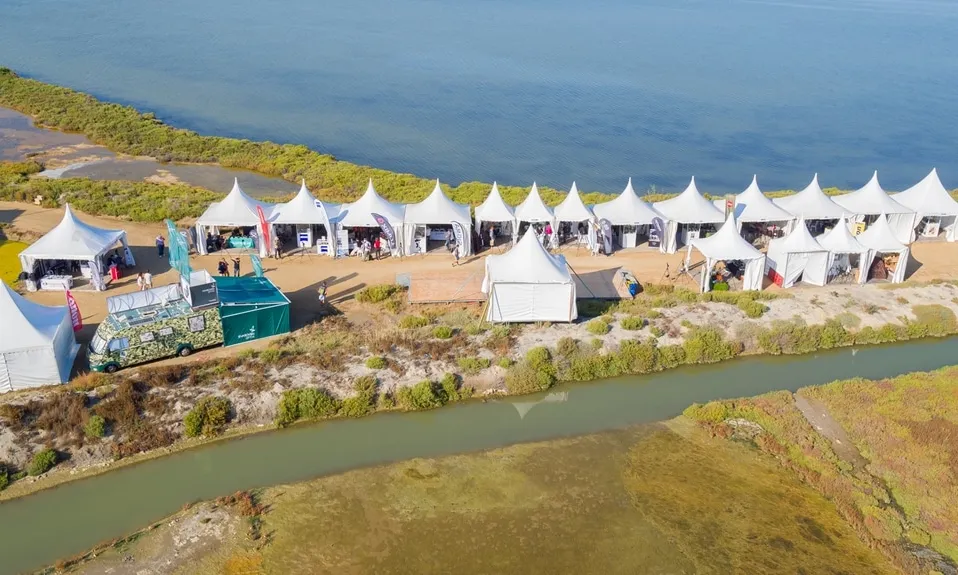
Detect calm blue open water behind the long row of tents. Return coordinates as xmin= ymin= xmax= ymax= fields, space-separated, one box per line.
xmin=0 ymin=0 xmax=958 ymax=192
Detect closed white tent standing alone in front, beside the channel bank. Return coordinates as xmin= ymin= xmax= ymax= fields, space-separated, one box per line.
xmin=482 ymin=229 xmax=578 ymax=322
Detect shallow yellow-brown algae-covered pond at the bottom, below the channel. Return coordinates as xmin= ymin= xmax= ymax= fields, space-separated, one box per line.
xmin=244 ymin=426 xmax=892 ymax=575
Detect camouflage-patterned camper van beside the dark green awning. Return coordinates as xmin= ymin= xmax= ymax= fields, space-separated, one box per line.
xmin=89 ymin=299 xmax=223 ymax=373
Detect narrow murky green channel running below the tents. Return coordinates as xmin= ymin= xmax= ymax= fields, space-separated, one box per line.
xmin=0 ymin=338 xmax=958 ymax=574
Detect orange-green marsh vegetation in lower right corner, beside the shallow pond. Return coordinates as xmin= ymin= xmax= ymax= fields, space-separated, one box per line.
xmin=685 ymin=366 xmax=958 ymax=573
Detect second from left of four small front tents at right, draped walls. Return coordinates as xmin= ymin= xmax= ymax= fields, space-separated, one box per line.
xmin=765 ymin=218 xmax=829 ymax=288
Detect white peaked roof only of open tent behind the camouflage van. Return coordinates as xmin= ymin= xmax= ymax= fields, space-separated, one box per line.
xmin=20 ymin=204 xmax=126 ymax=259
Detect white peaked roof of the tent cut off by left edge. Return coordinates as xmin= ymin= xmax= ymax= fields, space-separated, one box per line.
xmin=0 ymin=282 xmax=69 ymax=353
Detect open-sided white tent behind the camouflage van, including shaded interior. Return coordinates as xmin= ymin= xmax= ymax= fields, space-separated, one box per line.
xmin=20 ymin=204 xmax=136 ymax=291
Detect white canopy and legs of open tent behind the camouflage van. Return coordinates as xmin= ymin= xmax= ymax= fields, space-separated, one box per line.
xmin=20 ymin=204 xmax=136 ymax=291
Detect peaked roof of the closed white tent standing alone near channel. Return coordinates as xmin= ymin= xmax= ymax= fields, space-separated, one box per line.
xmin=483 ymin=228 xmax=572 ymax=287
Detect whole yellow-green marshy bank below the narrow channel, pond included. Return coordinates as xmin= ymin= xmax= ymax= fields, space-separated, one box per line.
xmin=47 ymin=368 xmax=958 ymax=575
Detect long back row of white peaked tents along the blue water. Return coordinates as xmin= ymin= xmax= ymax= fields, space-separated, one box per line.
xmin=196 ymin=169 xmax=958 ymax=256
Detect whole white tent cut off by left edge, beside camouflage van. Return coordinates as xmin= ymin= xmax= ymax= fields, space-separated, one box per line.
xmin=0 ymin=282 xmax=80 ymax=393
